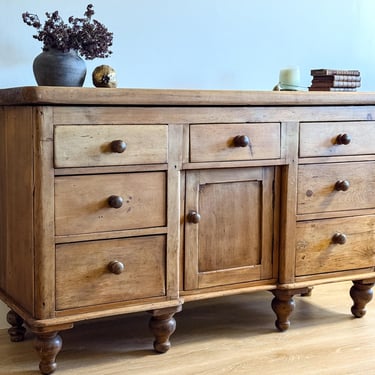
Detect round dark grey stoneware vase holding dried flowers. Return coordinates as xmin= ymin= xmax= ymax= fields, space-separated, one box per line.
xmin=33 ymin=49 xmax=86 ymax=87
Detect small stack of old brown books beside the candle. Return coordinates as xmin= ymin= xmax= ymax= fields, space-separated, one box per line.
xmin=309 ymin=69 xmax=361 ymax=91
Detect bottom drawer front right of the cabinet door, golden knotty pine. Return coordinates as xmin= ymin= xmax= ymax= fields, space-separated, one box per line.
xmin=296 ymin=215 xmax=375 ymax=276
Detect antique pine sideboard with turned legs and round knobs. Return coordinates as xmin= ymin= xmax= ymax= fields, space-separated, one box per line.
xmin=0 ymin=87 xmax=375 ymax=374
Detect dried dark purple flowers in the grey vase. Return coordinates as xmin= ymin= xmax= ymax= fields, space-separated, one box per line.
xmin=22 ymin=4 xmax=113 ymax=60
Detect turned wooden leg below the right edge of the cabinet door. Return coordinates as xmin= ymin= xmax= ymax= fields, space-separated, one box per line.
xmin=272 ymin=288 xmax=308 ymax=331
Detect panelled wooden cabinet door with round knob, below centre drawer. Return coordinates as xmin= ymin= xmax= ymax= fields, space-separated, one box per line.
xmin=184 ymin=167 xmax=274 ymax=290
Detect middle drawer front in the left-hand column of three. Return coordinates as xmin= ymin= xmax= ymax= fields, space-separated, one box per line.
xmin=55 ymin=172 xmax=166 ymax=235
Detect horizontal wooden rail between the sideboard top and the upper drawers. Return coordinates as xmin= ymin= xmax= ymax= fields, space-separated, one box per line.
xmin=54 ymin=106 xmax=375 ymax=125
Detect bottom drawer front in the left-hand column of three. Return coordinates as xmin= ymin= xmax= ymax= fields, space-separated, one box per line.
xmin=56 ymin=236 xmax=166 ymax=310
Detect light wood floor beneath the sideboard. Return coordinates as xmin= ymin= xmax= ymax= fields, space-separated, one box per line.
xmin=0 ymin=283 xmax=375 ymax=375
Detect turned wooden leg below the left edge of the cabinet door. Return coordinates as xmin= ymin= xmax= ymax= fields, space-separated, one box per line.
xmin=149 ymin=305 xmax=182 ymax=353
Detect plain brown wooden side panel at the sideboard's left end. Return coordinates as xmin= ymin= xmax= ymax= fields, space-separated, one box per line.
xmin=0 ymin=107 xmax=34 ymax=314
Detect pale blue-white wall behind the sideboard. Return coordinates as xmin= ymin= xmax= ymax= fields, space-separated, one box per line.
xmin=0 ymin=0 xmax=375 ymax=327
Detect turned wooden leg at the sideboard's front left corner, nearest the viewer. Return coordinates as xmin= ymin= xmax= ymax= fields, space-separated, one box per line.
xmin=34 ymin=332 xmax=62 ymax=375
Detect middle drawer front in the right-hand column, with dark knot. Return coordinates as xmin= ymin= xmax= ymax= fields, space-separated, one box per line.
xmin=297 ymin=162 xmax=375 ymax=214
